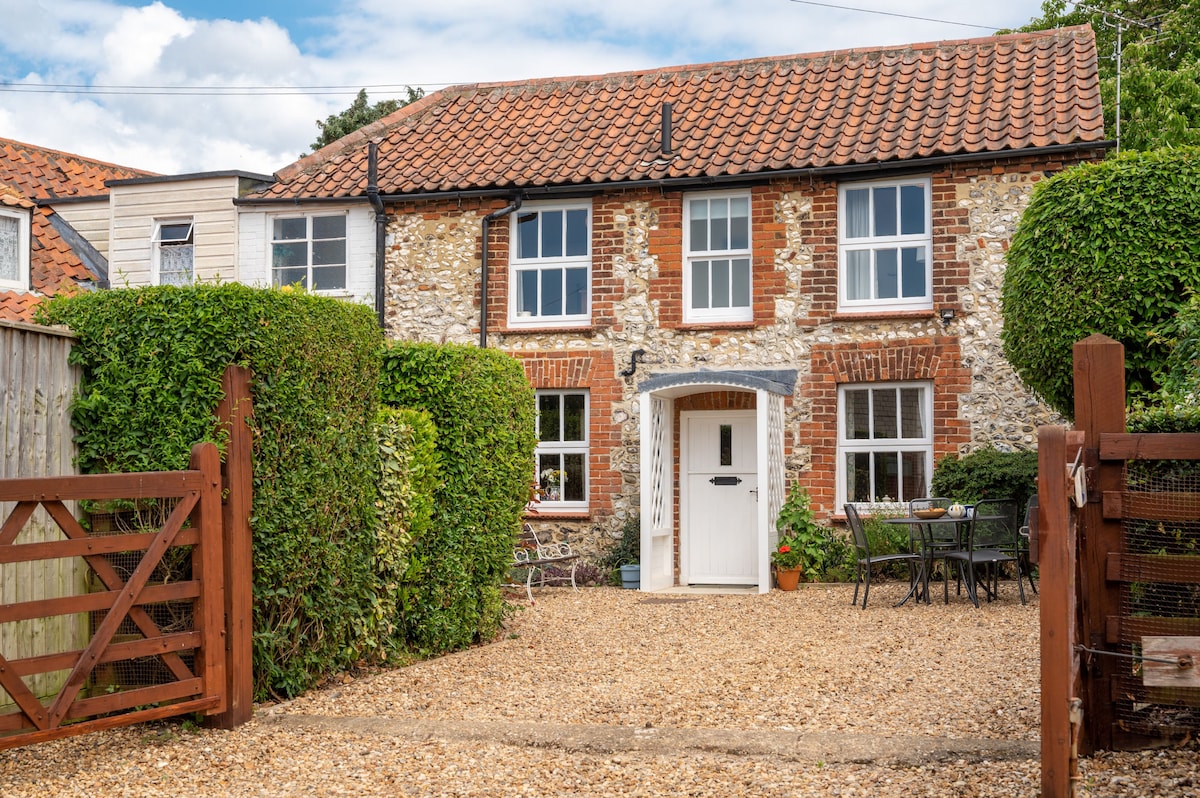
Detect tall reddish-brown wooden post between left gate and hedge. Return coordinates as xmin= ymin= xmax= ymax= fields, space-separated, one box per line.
xmin=205 ymin=366 xmax=254 ymax=728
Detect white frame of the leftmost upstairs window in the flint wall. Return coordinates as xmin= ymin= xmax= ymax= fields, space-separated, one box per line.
xmin=509 ymin=199 xmax=592 ymax=328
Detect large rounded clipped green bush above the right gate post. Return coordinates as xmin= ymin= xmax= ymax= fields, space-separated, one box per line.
xmin=1002 ymin=148 xmax=1200 ymax=416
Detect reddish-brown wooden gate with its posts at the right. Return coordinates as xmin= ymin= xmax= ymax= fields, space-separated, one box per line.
xmin=1037 ymin=336 xmax=1200 ymax=796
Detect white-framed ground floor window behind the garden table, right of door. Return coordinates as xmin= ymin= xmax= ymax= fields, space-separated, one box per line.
xmin=838 ymin=383 xmax=934 ymax=505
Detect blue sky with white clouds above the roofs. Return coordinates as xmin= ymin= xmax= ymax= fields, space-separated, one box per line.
xmin=0 ymin=0 xmax=1040 ymax=174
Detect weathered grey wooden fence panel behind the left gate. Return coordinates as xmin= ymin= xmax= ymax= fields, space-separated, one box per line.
xmin=0 ymin=320 xmax=81 ymax=712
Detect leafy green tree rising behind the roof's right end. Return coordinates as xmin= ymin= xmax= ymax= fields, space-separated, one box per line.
xmin=1021 ymin=0 xmax=1200 ymax=150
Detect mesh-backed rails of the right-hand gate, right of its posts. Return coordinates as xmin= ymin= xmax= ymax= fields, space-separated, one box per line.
xmin=1114 ymin=461 xmax=1200 ymax=738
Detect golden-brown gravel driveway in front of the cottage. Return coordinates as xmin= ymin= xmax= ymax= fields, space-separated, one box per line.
xmin=0 ymin=584 xmax=1200 ymax=798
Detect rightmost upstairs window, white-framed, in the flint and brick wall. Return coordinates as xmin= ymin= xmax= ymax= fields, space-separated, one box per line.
xmin=838 ymin=179 xmax=932 ymax=311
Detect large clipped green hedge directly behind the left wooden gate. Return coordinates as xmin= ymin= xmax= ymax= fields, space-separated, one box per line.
xmin=43 ymin=284 xmax=380 ymax=698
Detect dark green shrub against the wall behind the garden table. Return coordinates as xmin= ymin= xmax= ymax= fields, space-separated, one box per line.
xmin=930 ymin=446 xmax=1038 ymax=508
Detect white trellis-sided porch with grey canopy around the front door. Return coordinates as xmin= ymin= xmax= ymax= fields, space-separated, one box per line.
xmin=638 ymin=368 xmax=797 ymax=593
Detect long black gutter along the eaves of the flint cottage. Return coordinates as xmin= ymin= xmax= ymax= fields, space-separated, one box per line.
xmin=234 ymin=139 xmax=1116 ymax=205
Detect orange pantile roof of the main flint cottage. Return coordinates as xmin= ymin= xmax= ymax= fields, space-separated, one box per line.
xmin=253 ymin=25 xmax=1104 ymax=200
